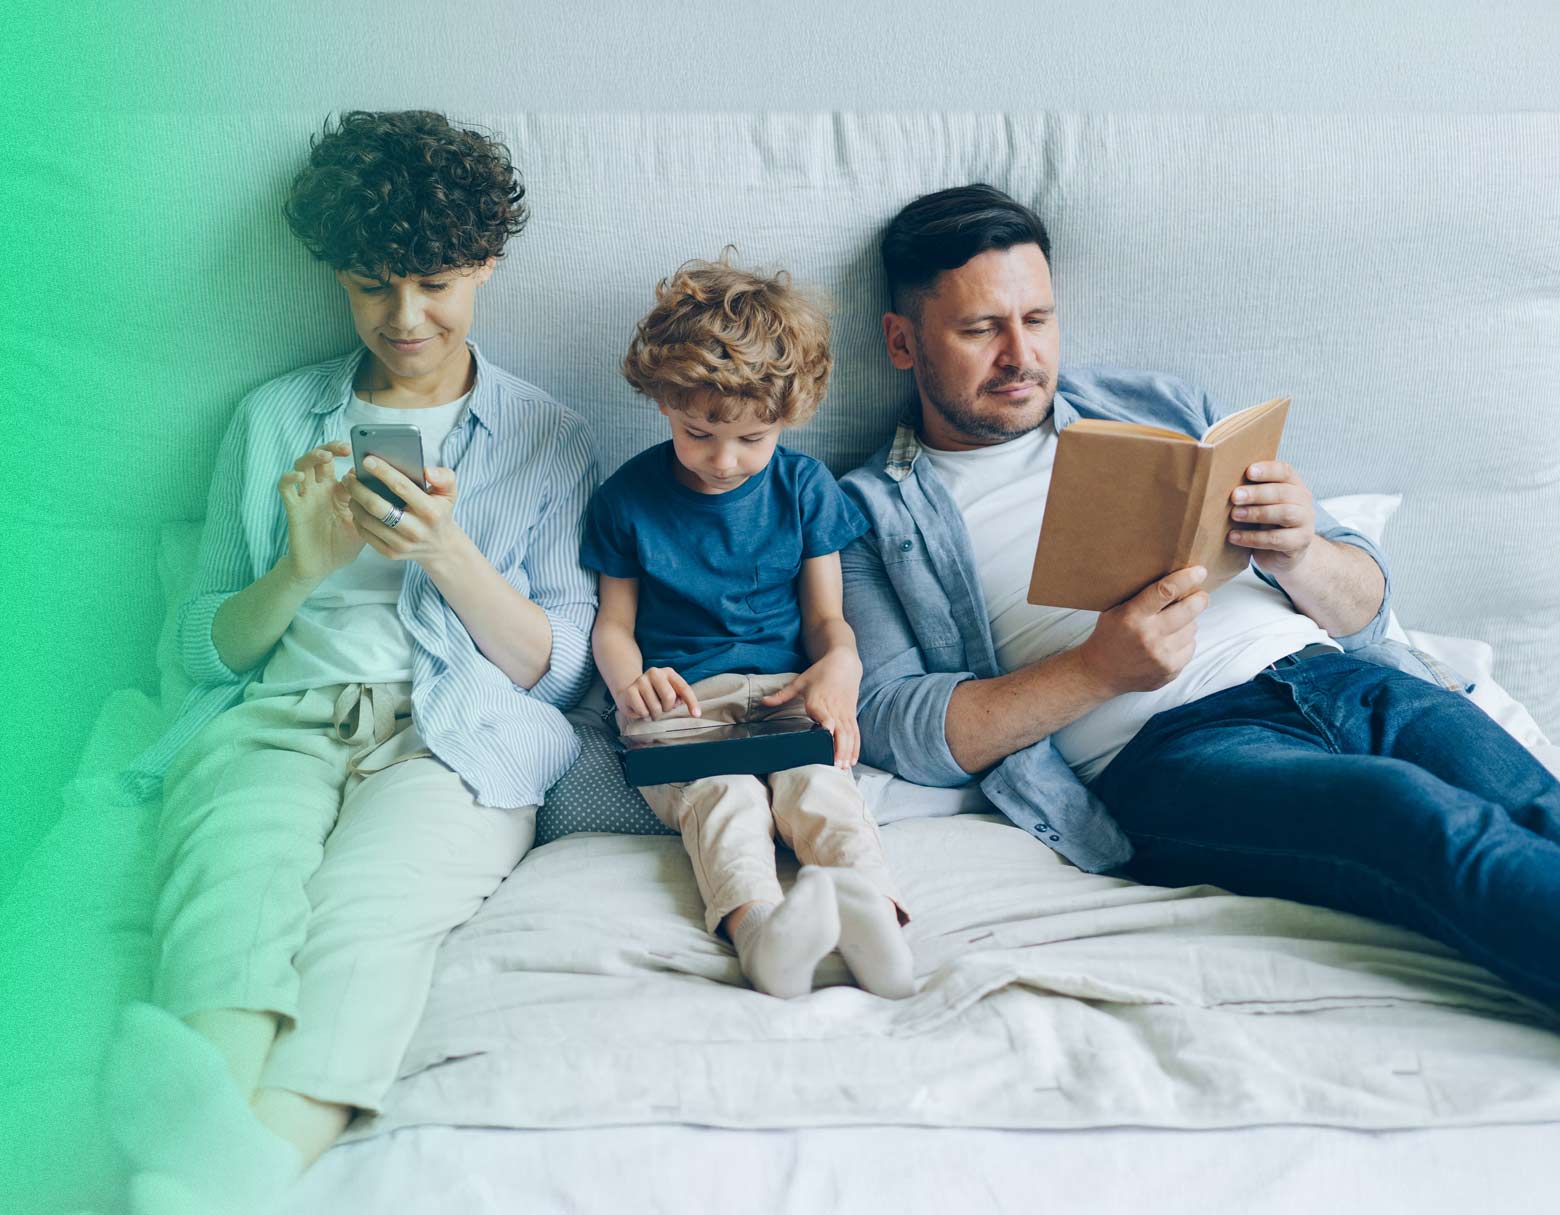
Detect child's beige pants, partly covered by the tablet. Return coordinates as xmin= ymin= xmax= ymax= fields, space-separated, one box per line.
xmin=618 ymin=675 xmax=908 ymax=933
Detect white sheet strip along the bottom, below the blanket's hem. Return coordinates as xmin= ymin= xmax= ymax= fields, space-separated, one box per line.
xmin=282 ymin=1126 xmax=1560 ymax=1215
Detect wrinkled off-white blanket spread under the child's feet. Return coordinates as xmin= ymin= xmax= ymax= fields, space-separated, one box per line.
xmin=354 ymin=814 xmax=1560 ymax=1135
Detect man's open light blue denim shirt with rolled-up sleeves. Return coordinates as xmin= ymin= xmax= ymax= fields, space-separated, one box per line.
xmin=841 ymin=368 xmax=1399 ymax=873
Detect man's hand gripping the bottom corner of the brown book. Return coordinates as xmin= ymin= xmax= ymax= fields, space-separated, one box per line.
xmin=1078 ymin=565 xmax=1207 ymax=696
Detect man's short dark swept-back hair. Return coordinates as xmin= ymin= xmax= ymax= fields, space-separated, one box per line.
xmin=883 ymin=182 xmax=1051 ymax=317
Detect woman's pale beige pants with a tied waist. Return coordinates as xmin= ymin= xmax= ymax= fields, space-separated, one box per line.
xmin=153 ymin=683 xmax=537 ymax=1111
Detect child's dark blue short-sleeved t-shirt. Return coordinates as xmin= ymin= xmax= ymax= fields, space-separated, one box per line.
xmin=580 ymin=441 xmax=867 ymax=683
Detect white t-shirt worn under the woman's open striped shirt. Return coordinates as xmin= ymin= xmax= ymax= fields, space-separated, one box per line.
xmin=253 ymin=393 xmax=470 ymax=696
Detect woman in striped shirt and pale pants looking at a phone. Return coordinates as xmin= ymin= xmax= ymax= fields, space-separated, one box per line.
xmin=103 ymin=111 xmax=596 ymax=1212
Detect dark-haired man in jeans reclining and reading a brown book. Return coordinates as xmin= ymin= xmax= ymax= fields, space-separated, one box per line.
xmin=844 ymin=186 xmax=1560 ymax=1003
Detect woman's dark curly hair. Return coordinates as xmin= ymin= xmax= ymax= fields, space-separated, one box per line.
xmin=285 ymin=109 xmax=530 ymax=279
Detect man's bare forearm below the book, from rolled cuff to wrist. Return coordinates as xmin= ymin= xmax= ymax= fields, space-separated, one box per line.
xmin=944 ymin=649 xmax=1112 ymax=772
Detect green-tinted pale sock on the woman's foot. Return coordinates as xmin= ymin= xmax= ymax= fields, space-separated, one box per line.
xmin=101 ymin=1004 xmax=303 ymax=1212
